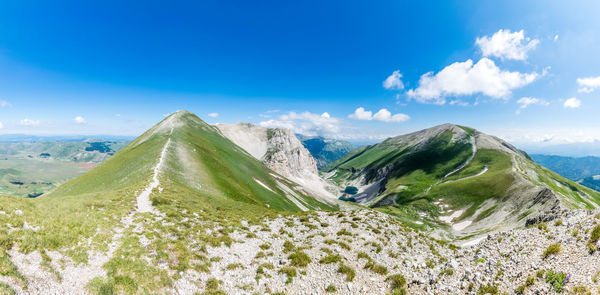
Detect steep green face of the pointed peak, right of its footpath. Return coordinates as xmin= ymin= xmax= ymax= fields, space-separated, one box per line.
xmin=163 ymin=114 xmax=331 ymax=211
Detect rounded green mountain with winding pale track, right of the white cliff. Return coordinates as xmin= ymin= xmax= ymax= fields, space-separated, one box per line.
xmin=325 ymin=124 xmax=600 ymax=237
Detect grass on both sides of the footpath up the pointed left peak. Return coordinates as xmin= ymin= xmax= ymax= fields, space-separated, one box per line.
xmin=0 ymin=113 xmax=335 ymax=276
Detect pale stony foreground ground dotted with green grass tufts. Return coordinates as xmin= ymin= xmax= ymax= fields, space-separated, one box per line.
xmin=0 ymin=210 xmax=600 ymax=294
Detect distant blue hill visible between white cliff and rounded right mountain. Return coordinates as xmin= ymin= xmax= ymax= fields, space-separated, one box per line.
xmin=296 ymin=134 xmax=356 ymax=170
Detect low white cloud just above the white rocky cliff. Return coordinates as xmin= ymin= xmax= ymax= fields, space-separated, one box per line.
xmin=259 ymin=112 xmax=342 ymax=136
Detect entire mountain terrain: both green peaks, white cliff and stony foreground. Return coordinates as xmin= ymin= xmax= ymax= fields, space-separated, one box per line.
xmin=0 ymin=111 xmax=600 ymax=294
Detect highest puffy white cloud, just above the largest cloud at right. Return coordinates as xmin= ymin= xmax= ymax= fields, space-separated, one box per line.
xmin=475 ymin=30 xmax=540 ymax=60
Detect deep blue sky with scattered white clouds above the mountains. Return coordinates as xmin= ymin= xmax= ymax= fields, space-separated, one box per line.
xmin=0 ymin=1 xmax=600 ymax=146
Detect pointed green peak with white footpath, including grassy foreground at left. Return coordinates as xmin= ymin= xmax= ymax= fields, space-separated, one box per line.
xmin=0 ymin=111 xmax=337 ymax=294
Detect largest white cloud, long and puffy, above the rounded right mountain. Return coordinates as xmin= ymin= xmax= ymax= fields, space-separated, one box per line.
xmin=407 ymin=57 xmax=539 ymax=104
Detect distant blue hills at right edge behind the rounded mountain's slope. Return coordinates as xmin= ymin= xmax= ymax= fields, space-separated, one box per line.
xmin=531 ymin=154 xmax=600 ymax=191
